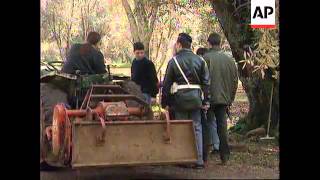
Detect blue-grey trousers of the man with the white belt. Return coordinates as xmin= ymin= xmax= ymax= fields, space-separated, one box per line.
xmin=175 ymin=109 xmax=203 ymax=165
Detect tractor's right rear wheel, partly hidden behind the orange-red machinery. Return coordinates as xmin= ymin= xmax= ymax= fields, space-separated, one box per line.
xmin=121 ymin=80 xmax=154 ymax=120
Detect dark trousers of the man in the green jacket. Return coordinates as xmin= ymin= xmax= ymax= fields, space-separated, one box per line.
xmin=208 ymin=105 xmax=230 ymax=160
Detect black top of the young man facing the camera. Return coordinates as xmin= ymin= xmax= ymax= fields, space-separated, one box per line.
xmin=131 ymin=57 xmax=159 ymax=97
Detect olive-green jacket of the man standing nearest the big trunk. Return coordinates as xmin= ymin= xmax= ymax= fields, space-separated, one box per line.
xmin=203 ymin=48 xmax=238 ymax=105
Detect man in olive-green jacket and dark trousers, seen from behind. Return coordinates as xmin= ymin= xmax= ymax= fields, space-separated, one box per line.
xmin=203 ymin=33 xmax=238 ymax=164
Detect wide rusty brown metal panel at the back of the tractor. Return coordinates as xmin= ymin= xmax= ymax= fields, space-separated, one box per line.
xmin=71 ymin=120 xmax=197 ymax=168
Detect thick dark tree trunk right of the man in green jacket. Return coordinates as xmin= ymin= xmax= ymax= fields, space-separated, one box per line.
xmin=211 ymin=0 xmax=279 ymax=130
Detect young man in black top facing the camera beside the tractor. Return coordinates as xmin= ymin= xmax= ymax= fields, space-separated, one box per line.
xmin=131 ymin=42 xmax=159 ymax=105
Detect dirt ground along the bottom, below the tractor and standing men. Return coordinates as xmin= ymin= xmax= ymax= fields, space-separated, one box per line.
xmin=40 ymin=139 xmax=279 ymax=180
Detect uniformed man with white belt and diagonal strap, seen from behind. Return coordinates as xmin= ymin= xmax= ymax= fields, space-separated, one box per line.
xmin=161 ymin=33 xmax=210 ymax=168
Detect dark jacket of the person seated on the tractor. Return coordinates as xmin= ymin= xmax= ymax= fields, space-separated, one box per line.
xmin=61 ymin=44 xmax=107 ymax=75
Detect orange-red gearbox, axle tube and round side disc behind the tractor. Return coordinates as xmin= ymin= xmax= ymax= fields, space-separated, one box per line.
xmin=52 ymin=102 xmax=145 ymax=164
